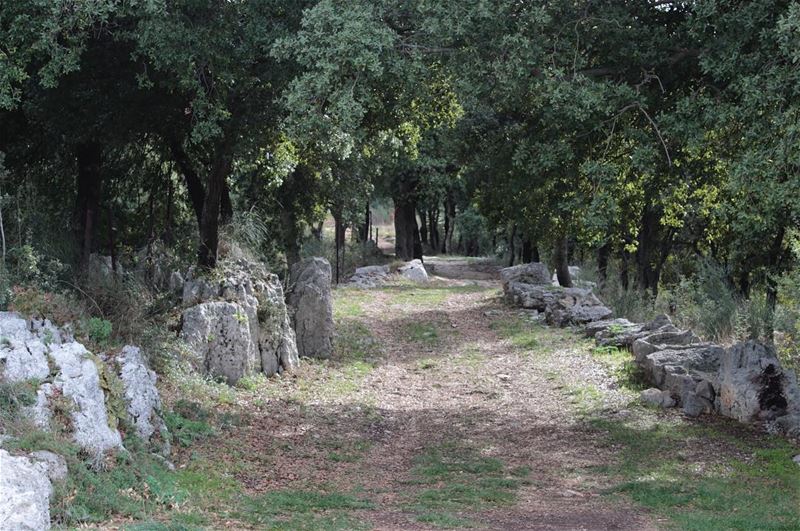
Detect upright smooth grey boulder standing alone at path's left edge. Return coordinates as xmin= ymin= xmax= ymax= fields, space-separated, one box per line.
xmin=288 ymin=258 xmax=332 ymax=359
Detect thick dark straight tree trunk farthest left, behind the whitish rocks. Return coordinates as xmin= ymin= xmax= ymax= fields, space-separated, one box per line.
xmin=75 ymin=142 xmax=103 ymax=266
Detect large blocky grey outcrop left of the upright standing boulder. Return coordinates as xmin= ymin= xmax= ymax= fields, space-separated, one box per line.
xmin=179 ymin=259 xmax=299 ymax=384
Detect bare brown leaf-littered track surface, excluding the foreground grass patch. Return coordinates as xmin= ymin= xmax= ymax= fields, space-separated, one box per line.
xmin=223 ymin=261 xmax=654 ymax=530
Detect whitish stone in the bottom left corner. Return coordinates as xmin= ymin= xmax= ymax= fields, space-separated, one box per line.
xmin=0 ymin=450 xmax=53 ymax=531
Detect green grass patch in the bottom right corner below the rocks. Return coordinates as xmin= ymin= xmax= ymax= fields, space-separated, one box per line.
xmin=593 ymin=420 xmax=800 ymax=530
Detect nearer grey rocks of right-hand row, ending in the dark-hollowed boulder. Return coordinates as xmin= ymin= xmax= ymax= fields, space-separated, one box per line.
xmin=586 ymin=315 xmax=800 ymax=436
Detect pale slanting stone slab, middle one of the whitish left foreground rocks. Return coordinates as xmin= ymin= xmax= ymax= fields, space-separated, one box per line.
xmin=50 ymin=342 xmax=122 ymax=454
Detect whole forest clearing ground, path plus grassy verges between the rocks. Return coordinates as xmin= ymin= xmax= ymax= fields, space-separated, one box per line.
xmin=115 ymin=260 xmax=800 ymax=531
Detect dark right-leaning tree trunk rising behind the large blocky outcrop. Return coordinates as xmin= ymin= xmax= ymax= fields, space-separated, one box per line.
xmin=197 ymin=141 xmax=233 ymax=269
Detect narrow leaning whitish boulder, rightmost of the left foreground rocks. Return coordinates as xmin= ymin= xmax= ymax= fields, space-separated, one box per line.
xmin=115 ymin=345 xmax=169 ymax=454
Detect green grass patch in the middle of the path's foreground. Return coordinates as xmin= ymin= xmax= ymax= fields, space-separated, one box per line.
xmin=409 ymin=443 xmax=530 ymax=527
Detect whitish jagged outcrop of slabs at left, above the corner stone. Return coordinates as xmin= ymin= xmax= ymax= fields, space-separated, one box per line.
xmin=0 ymin=312 xmax=169 ymax=456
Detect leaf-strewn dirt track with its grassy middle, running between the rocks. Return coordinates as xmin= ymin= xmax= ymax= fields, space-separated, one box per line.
xmin=173 ymin=262 xmax=653 ymax=530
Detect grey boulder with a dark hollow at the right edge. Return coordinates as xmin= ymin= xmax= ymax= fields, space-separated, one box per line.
xmin=716 ymin=341 xmax=800 ymax=422
